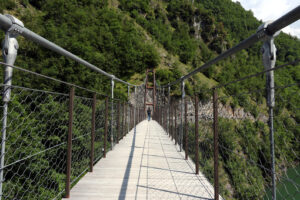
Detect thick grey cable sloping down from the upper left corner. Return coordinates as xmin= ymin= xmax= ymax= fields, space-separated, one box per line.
xmin=0 ymin=14 xmax=137 ymax=86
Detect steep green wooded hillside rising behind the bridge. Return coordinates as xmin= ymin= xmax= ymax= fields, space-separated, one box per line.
xmin=0 ymin=0 xmax=300 ymax=199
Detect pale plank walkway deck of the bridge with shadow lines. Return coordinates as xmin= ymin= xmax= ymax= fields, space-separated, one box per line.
xmin=63 ymin=121 xmax=221 ymax=200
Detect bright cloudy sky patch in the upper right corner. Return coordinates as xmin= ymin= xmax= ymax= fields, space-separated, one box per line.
xmin=232 ymin=0 xmax=300 ymax=38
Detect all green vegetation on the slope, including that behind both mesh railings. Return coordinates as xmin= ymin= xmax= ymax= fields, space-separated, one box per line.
xmin=0 ymin=0 xmax=300 ymax=199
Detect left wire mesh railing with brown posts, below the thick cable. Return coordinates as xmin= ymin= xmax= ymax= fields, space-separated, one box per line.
xmin=1 ymin=63 xmax=139 ymax=200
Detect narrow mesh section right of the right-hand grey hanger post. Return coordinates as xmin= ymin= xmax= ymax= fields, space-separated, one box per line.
xmin=267 ymin=82 xmax=300 ymax=200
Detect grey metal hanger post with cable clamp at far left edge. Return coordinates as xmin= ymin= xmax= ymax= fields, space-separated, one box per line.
xmin=0 ymin=15 xmax=24 ymax=199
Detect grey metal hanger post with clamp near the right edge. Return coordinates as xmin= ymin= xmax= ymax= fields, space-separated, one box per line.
xmin=258 ymin=22 xmax=279 ymax=200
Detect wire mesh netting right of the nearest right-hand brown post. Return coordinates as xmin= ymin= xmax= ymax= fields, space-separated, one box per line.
xmin=218 ymin=76 xmax=300 ymax=200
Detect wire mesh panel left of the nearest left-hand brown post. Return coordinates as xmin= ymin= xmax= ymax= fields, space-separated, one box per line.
xmin=1 ymin=86 xmax=69 ymax=199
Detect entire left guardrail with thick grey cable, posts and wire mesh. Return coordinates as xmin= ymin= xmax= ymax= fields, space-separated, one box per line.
xmin=0 ymin=11 xmax=143 ymax=199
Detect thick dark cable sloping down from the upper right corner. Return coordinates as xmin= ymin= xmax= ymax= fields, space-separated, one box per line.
xmin=160 ymin=6 xmax=300 ymax=87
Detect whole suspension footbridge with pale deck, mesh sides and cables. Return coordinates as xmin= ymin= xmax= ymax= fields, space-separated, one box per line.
xmin=0 ymin=6 xmax=300 ymax=200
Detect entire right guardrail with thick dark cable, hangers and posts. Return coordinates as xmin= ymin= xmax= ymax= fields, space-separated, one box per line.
xmin=155 ymin=6 xmax=300 ymax=200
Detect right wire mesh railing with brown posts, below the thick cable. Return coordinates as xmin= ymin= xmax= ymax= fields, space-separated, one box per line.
xmin=155 ymin=61 xmax=300 ymax=200
